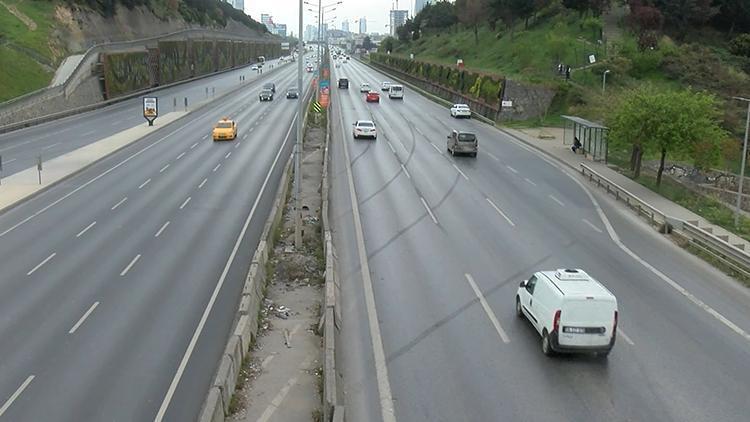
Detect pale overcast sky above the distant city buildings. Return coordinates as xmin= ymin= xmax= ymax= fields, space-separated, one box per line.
xmin=245 ymin=0 xmax=414 ymax=35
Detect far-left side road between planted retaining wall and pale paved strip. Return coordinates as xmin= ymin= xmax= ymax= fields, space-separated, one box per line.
xmin=0 ymin=56 xmax=283 ymax=176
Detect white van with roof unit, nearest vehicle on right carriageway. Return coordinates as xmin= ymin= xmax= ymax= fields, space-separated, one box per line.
xmin=516 ymin=269 xmax=617 ymax=357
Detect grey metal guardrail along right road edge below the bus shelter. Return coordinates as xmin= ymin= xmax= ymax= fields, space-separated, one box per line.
xmin=580 ymin=163 xmax=750 ymax=277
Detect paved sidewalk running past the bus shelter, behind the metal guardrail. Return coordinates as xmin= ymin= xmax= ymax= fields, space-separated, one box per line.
xmin=501 ymin=127 xmax=750 ymax=251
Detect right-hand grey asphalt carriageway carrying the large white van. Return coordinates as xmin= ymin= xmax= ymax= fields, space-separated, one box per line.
xmin=331 ymin=57 xmax=750 ymax=422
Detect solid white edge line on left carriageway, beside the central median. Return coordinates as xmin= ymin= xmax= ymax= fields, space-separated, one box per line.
xmin=154 ymin=115 xmax=302 ymax=422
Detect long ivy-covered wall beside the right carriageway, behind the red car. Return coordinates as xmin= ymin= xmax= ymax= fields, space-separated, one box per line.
xmin=370 ymin=53 xmax=503 ymax=105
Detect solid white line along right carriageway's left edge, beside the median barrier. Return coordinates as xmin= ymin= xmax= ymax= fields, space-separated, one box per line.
xmin=339 ymin=106 xmax=396 ymax=422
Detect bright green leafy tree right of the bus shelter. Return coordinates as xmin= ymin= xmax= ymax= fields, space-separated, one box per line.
xmin=607 ymin=86 xmax=727 ymax=187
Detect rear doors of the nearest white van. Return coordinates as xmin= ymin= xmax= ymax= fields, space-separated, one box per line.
xmin=558 ymin=297 xmax=617 ymax=347
